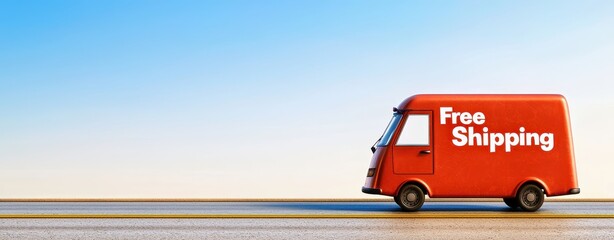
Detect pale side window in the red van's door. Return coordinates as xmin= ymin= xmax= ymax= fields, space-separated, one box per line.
xmin=397 ymin=114 xmax=430 ymax=146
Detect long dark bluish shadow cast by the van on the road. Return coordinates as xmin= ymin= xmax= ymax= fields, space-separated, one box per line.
xmin=265 ymin=202 xmax=514 ymax=213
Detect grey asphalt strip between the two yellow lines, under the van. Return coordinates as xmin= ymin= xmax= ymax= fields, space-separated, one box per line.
xmin=0 ymin=202 xmax=614 ymax=218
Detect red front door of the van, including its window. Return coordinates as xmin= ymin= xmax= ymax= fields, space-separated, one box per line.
xmin=392 ymin=111 xmax=433 ymax=174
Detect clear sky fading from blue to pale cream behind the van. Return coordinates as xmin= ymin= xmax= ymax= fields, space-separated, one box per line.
xmin=0 ymin=1 xmax=614 ymax=198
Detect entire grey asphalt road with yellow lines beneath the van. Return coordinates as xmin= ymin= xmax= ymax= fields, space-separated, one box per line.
xmin=0 ymin=202 xmax=614 ymax=239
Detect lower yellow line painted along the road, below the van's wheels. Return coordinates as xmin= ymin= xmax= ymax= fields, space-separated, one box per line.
xmin=0 ymin=213 xmax=614 ymax=219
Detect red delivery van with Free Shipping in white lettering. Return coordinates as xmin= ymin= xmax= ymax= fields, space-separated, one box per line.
xmin=362 ymin=94 xmax=580 ymax=211
